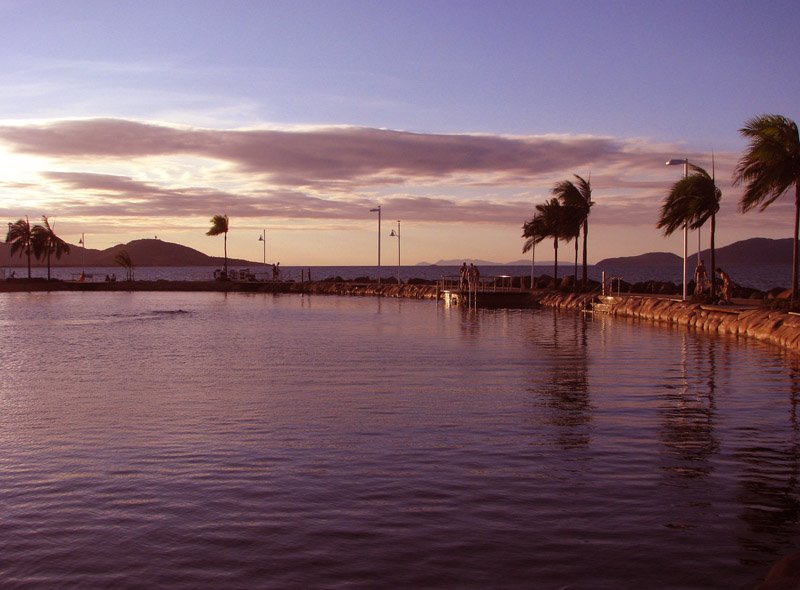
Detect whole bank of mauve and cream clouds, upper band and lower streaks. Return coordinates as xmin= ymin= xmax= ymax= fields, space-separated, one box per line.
xmin=0 ymin=119 xmax=764 ymax=226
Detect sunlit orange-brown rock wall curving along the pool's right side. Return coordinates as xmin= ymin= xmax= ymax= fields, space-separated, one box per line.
xmin=540 ymin=293 xmax=800 ymax=352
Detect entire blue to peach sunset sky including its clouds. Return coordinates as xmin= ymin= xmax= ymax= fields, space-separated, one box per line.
xmin=0 ymin=0 xmax=800 ymax=266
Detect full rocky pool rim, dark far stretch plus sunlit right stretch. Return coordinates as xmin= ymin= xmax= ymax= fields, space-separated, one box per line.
xmin=6 ymin=279 xmax=800 ymax=353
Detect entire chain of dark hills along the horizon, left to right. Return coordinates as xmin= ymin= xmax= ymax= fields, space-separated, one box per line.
xmin=0 ymin=238 xmax=792 ymax=268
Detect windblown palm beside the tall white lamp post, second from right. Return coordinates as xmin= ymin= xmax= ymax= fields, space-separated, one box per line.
xmin=656 ymin=164 xmax=722 ymax=296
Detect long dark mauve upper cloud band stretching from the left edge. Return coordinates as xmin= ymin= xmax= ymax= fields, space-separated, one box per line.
xmin=0 ymin=119 xmax=620 ymax=186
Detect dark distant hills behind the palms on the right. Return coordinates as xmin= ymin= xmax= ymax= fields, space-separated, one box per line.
xmin=596 ymin=238 xmax=792 ymax=268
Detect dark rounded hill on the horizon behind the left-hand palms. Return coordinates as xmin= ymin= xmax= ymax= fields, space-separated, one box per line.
xmin=0 ymin=239 xmax=255 ymax=267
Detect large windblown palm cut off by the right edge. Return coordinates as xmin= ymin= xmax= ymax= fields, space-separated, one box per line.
xmin=733 ymin=115 xmax=800 ymax=303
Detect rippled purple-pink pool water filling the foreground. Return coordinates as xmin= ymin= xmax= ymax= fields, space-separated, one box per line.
xmin=0 ymin=292 xmax=800 ymax=590
